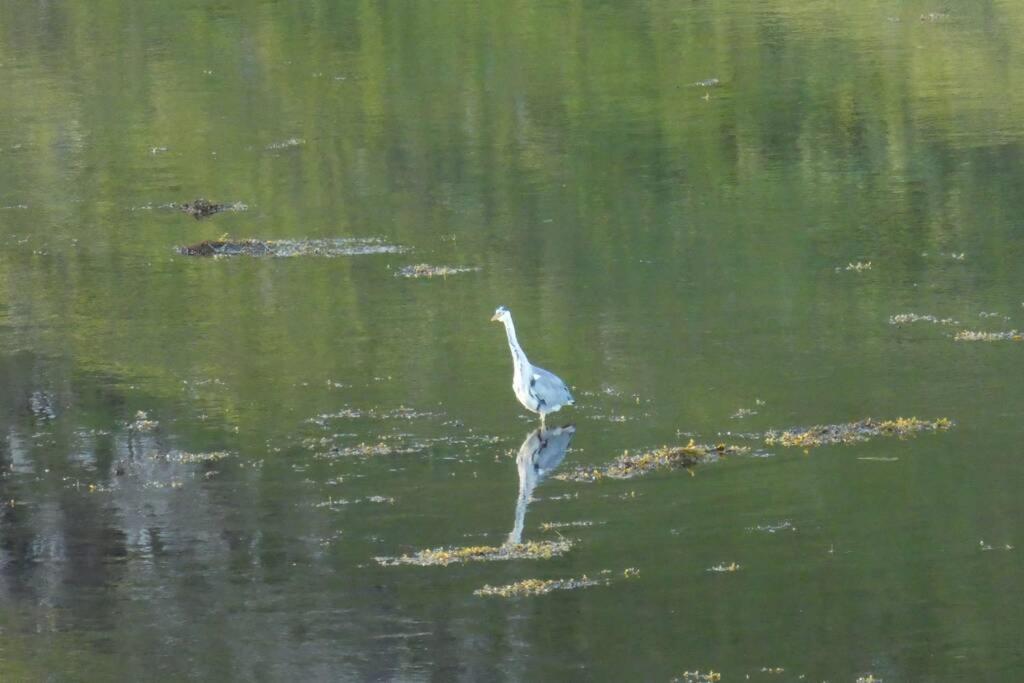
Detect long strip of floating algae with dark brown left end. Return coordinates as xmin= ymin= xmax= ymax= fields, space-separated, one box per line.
xmin=177 ymin=238 xmax=406 ymax=257
